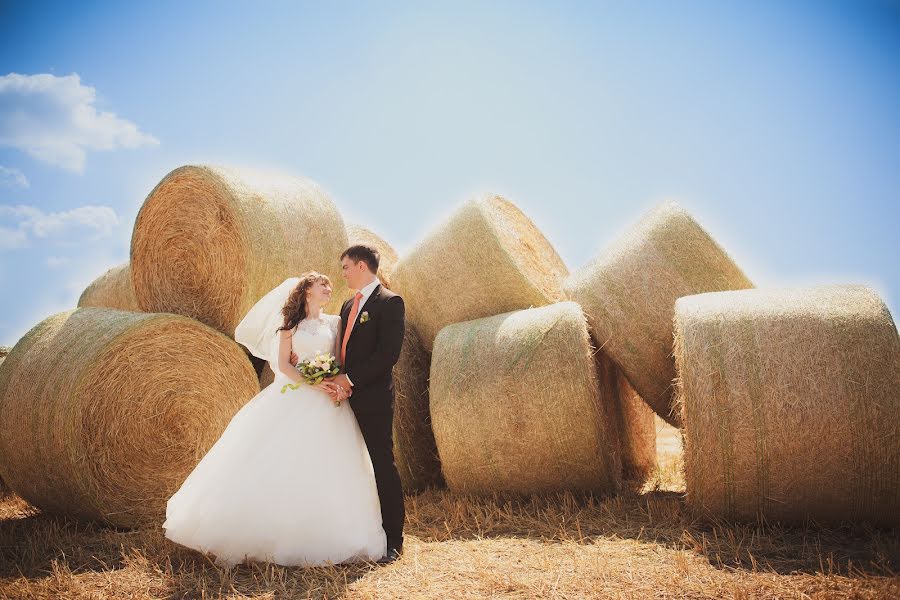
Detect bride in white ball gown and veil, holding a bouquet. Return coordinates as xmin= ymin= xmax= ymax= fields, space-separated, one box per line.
xmin=162 ymin=272 xmax=387 ymax=567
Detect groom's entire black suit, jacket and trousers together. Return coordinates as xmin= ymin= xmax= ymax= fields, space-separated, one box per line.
xmin=341 ymin=285 xmax=406 ymax=549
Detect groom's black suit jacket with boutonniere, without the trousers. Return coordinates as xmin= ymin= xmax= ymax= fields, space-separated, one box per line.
xmin=340 ymin=284 xmax=406 ymax=415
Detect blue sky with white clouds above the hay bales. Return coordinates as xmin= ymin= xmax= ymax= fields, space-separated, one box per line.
xmin=0 ymin=0 xmax=900 ymax=344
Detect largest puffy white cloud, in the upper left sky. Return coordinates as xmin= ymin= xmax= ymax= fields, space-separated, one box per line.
xmin=0 ymin=73 xmax=159 ymax=173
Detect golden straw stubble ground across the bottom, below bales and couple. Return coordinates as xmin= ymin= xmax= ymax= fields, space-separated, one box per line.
xmin=0 ymin=462 xmax=900 ymax=600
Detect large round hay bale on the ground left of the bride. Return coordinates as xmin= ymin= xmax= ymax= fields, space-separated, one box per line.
xmin=0 ymin=308 xmax=259 ymax=526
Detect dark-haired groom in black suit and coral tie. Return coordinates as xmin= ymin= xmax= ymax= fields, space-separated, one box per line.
xmin=332 ymin=245 xmax=406 ymax=564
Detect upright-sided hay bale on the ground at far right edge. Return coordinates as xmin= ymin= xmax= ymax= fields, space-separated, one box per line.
xmin=675 ymin=286 xmax=900 ymax=526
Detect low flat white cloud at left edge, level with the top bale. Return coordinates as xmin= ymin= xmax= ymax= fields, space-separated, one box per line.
xmin=0 ymin=204 xmax=119 ymax=247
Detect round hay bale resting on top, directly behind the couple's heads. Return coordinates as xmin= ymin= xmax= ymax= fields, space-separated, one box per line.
xmin=131 ymin=165 xmax=347 ymax=337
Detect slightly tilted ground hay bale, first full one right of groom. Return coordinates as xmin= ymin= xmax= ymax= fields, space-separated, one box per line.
xmin=430 ymin=302 xmax=622 ymax=493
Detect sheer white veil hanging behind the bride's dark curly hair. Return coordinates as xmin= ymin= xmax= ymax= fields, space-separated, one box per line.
xmin=234 ymin=277 xmax=300 ymax=374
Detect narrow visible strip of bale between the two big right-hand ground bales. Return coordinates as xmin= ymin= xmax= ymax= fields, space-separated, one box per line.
xmin=607 ymin=358 xmax=656 ymax=482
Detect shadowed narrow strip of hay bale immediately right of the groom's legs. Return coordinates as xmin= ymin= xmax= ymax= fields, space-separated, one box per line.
xmin=394 ymin=323 xmax=444 ymax=492
